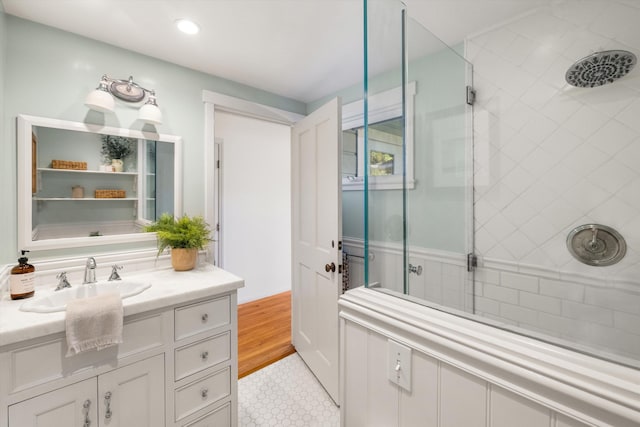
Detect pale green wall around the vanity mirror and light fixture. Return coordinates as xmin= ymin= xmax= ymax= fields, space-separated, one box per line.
xmin=0 ymin=13 xmax=306 ymax=264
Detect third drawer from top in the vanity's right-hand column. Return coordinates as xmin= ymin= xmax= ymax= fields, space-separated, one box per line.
xmin=175 ymin=367 xmax=231 ymax=421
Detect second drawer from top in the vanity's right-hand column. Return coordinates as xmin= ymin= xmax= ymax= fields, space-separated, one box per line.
xmin=175 ymin=332 xmax=231 ymax=381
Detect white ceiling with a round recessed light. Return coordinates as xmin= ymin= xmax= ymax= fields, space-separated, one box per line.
xmin=1 ymin=0 xmax=550 ymax=102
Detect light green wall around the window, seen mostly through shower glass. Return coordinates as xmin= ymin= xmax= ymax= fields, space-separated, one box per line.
xmin=332 ymin=46 xmax=470 ymax=253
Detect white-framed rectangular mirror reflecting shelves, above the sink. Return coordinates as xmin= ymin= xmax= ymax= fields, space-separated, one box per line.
xmin=17 ymin=115 xmax=182 ymax=250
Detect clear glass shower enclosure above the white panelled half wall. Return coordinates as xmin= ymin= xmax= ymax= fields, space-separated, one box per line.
xmin=362 ymin=0 xmax=640 ymax=368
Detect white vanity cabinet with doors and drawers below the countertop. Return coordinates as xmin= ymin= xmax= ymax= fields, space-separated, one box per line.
xmin=0 ymin=272 xmax=242 ymax=427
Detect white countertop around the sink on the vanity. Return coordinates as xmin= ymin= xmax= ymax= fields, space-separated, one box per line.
xmin=0 ymin=264 xmax=244 ymax=347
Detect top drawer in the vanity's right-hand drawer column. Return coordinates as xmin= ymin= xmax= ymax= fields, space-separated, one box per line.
xmin=175 ymin=296 xmax=231 ymax=341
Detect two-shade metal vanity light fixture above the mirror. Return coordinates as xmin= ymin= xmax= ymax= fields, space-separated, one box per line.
xmin=85 ymin=74 xmax=162 ymax=125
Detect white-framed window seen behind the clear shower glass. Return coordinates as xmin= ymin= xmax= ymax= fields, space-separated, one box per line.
xmin=342 ymin=82 xmax=416 ymax=190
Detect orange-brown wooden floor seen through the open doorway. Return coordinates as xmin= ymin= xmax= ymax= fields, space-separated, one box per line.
xmin=238 ymin=291 xmax=296 ymax=378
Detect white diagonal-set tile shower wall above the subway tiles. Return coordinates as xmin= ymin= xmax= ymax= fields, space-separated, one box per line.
xmin=466 ymin=0 xmax=640 ymax=286
